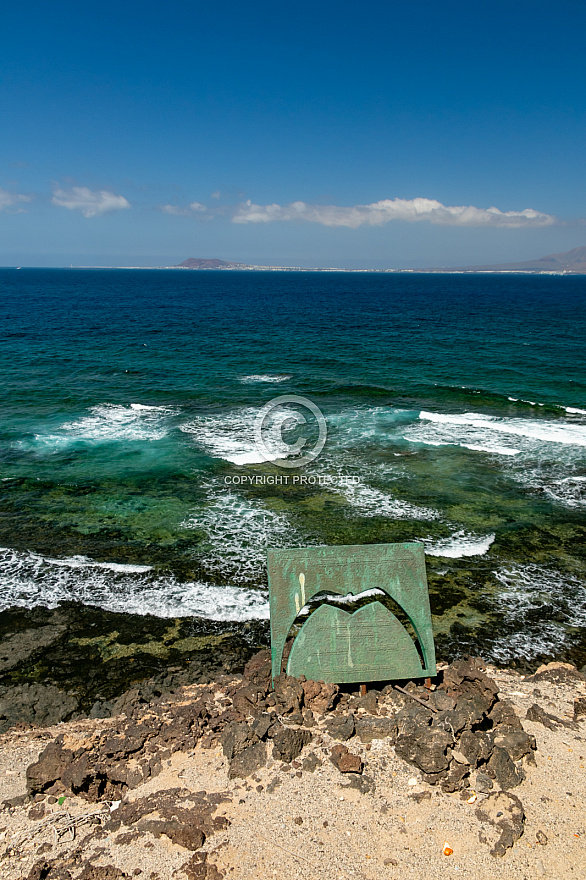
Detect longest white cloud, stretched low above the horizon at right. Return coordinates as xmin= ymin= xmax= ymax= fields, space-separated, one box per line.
xmin=232 ymin=199 xmax=557 ymax=229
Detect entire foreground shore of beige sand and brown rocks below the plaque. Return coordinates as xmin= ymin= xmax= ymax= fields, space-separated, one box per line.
xmin=0 ymin=650 xmax=586 ymax=880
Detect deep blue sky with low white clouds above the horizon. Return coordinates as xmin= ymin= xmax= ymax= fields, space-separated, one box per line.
xmin=0 ymin=0 xmax=586 ymax=268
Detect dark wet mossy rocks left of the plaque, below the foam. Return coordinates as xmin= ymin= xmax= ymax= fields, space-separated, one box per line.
xmin=0 ymin=602 xmax=269 ymax=733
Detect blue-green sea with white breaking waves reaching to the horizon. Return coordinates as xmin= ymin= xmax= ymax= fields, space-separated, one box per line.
xmin=0 ymin=269 xmax=586 ymax=665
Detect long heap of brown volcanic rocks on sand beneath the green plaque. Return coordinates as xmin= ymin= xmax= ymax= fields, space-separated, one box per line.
xmin=27 ymin=651 xmax=536 ymax=801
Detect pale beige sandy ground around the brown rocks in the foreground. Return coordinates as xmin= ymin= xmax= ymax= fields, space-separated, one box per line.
xmin=0 ymin=667 xmax=586 ymax=880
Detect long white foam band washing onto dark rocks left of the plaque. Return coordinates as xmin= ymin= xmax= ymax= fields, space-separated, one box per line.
xmin=0 ymin=548 xmax=269 ymax=621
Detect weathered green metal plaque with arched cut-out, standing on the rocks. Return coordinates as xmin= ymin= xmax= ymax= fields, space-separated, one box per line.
xmin=267 ymin=543 xmax=436 ymax=684
